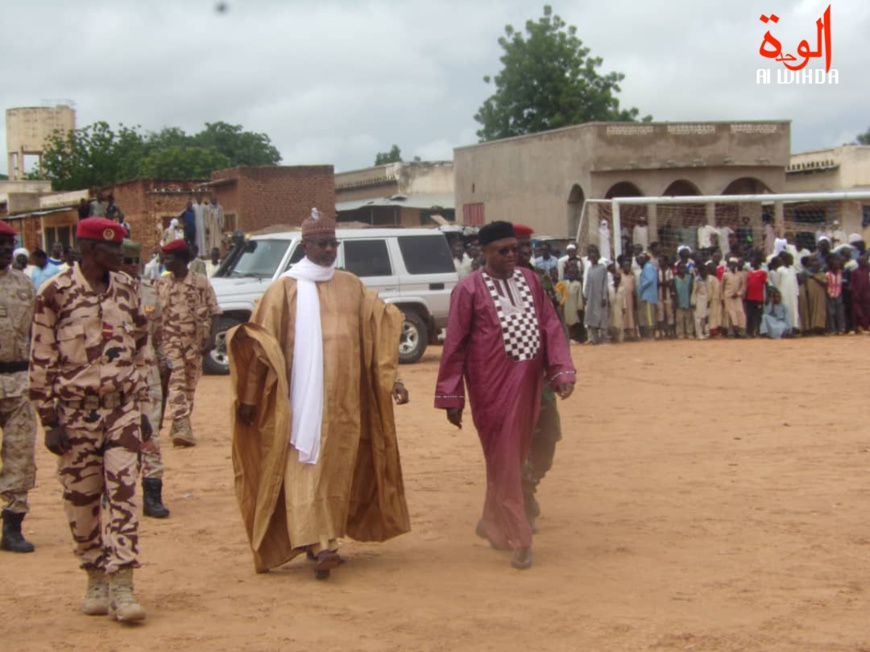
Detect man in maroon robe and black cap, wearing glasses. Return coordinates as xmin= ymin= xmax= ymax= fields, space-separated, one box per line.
xmin=435 ymin=222 xmax=575 ymax=569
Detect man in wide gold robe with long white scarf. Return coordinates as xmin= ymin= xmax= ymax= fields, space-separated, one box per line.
xmin=228 ymin=211 xmax=410 ymax=579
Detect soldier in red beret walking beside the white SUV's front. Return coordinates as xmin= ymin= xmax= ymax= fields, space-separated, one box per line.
xmin=157 ymin=240 xmax=221 ymax=446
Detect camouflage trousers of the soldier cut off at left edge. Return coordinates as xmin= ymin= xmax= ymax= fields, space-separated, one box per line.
xmin=0 ymin=396 xmax=36 ymax=514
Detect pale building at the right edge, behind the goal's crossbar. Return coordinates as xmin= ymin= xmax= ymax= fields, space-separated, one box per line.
xmin=785 ymin=145 xmax=870 ymax=242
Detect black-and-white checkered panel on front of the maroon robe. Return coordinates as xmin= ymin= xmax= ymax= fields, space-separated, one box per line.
xmin=483 ymin=269 xmax=541 ymax=362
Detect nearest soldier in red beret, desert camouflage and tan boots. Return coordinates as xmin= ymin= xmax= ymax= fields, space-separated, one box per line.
xmin=30 ymin=217 xmax=151 ymax=622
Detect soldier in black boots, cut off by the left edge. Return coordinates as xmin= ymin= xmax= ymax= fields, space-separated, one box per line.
xmin=0 ymin=221 xmax=36 ymax=552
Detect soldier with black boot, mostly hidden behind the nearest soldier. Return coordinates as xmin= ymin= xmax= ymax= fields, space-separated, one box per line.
xmin=122 ymin=240 xmax=169 ymax=518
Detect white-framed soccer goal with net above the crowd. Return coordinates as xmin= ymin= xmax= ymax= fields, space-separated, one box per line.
xmin=576 ymin=191 xmax=870 ymax=259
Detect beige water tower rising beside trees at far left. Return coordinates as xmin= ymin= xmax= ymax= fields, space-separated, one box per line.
xmin=6 ymin=103 xmax=76 ymax=181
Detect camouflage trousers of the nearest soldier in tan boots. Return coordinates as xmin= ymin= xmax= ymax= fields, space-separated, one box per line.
xmin=58 ymin=403 xmax=141 ymax=573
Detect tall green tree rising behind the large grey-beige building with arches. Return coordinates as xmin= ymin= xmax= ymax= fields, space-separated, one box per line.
xmin=474 ymin=5 xmax=652 ymax=141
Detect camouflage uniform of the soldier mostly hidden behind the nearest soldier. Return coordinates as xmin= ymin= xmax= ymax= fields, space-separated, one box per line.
xmin=139 ymin=279 xmax=166 ymax=479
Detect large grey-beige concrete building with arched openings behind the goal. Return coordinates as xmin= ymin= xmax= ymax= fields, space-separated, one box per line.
xmin=454 ymin=121 xmax=790 ymax=250
